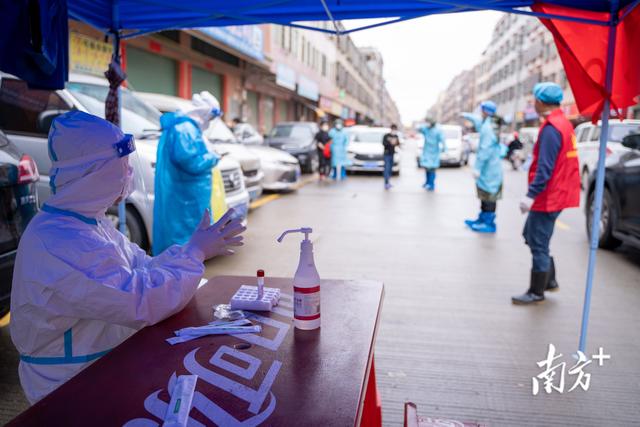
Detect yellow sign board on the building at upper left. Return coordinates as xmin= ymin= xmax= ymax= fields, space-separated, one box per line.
xmin=69 ymin=32 xmax=113 ymax=76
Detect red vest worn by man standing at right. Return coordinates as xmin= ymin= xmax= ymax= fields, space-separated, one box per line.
xmin=529 ymin=109 xmax=580 ymax=212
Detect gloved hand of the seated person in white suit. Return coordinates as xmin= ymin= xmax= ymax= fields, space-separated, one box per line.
xmin=185 ymin=209 xmax=246 ymax=261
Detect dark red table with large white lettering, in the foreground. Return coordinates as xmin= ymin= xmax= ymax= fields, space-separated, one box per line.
xmin=9 ymin=277 xmax=384 ymax=427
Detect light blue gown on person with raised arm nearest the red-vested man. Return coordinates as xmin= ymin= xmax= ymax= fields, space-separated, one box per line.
xmin=463 ymin=113 xmax=503 ymax=194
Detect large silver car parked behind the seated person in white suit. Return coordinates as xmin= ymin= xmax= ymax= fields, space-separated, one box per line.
xmin=0 ymin=74 xmax=249 ymax=249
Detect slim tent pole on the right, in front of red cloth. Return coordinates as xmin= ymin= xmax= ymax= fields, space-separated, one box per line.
xmin=578 ymin=0 xmax=618 ymax=353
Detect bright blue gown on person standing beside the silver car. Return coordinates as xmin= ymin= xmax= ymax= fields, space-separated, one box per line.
xmin=153 ymin=113 xmax=219 ymax=254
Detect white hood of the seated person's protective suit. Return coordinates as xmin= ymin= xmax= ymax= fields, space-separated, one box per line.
xmin=46 ymin=111 xmax=132 ymax=218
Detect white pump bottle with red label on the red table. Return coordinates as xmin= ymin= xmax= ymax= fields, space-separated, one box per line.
xmin=278 ymin=228 xmax=320 ymax=330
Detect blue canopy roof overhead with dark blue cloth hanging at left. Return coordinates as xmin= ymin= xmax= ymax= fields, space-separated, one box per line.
xmin=0 ymin=0 xmax=638 ymax=88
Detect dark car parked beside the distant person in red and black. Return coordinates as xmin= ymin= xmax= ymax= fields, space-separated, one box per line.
xmin=266 ymin=122 xmax=319 ymax=173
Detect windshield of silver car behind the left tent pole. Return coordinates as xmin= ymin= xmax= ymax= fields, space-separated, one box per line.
xmin=67 ymin=83 xmax=160 ymax=136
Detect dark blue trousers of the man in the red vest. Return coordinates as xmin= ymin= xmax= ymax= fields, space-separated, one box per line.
xmin=522 ymin=211 xmax=562 ymax=272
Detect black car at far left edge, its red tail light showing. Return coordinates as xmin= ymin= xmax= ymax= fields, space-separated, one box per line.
xmin=0 ymin=131 xmax=40 ymax=317
